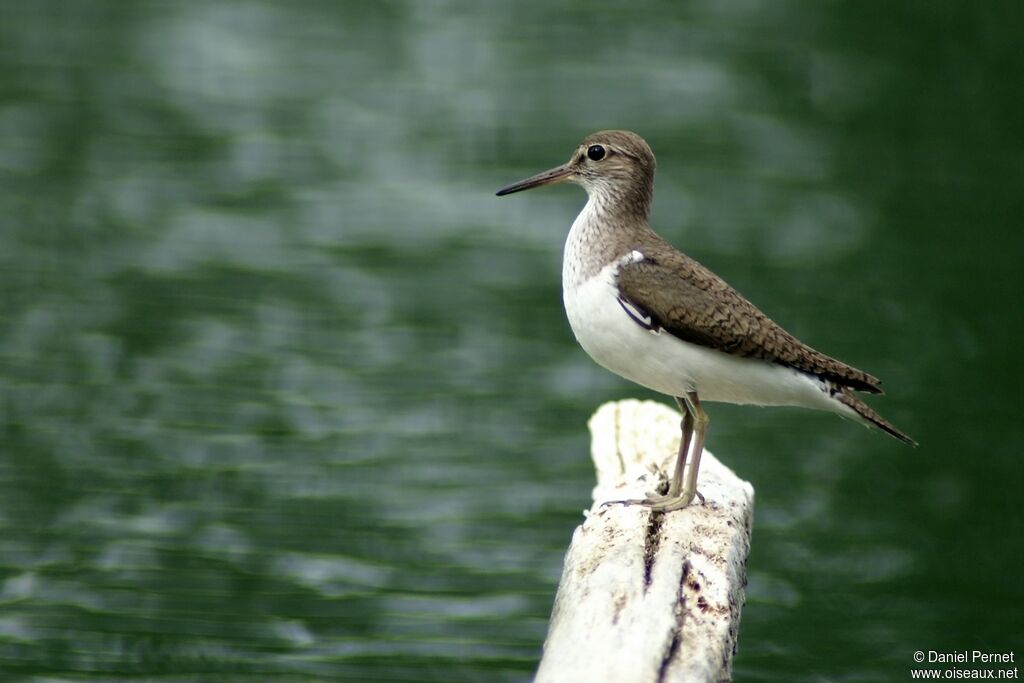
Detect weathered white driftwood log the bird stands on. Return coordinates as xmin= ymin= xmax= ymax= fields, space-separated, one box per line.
xmin=536 ymin=400 xmax=754 ymax=683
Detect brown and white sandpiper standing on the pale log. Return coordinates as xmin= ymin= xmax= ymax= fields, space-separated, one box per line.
xmin=498 ymin=130 xmax=914 ymax=512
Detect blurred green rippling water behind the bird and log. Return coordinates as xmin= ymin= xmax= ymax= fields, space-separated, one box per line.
xmin=0 ymin=0 xmax=1024 ymax=681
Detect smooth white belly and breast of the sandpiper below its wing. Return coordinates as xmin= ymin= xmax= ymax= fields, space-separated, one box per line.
xmin=563 ymin=263 xmax=838 ymax=411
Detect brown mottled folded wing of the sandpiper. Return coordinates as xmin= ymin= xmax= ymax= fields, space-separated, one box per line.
xmin=618 ymin=250 xmax=882 ymax=393
